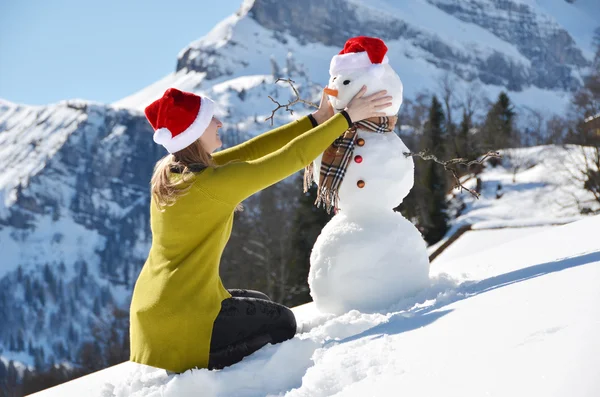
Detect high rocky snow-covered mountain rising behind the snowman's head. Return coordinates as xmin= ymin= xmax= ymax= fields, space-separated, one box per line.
xmin=116 ymin=0 xmax=600 ymax=117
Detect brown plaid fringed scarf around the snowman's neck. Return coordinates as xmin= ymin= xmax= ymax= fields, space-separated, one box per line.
xmin=304 ymin=116 xmax=398 ymax=213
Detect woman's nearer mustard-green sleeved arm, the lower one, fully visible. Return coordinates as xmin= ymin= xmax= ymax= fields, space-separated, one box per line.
xmin=198 ymin=113 xmax=351 ymax=205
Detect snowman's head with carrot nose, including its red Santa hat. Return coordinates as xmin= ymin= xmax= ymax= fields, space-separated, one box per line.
xmin=325 ymin=36 xmax=402 ymax=116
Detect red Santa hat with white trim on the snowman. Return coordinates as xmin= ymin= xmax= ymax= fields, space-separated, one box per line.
xmin=329 ymin=36 xmax=389 ymax=77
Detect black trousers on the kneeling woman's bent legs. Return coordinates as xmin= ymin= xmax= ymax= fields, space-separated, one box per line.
xmin=209 ymin=297 xmax=296 ymax=369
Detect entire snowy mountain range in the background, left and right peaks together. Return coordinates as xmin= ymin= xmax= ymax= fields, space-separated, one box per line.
xmin=0 ymin=0 xmax=600 ymax=378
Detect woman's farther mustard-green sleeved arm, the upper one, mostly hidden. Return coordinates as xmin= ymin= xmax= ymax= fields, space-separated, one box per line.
xmin=213 ymin=116 xmax=313 ymax=165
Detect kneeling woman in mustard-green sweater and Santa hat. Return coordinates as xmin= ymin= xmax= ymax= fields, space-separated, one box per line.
xmin=130 ymin=87 xmax=391 ymax=373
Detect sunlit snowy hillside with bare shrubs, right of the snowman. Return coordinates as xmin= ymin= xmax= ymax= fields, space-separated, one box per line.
xmin=428 ymin=145 xmax=600 ymax=261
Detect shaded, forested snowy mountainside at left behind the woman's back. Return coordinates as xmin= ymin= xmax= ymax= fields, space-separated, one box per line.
xmin=0 ymin=101 xmax=162 ymax=365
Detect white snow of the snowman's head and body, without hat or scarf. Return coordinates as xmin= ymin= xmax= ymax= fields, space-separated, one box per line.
xmin=308 ymin=46 xmax=429 ymax=314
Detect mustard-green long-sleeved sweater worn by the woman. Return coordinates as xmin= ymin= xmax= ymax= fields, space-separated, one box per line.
xmin=130 ymin=114 xmax=348 ymax=372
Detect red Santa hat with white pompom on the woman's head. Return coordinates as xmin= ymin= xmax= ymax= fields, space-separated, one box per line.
xmin=145 ymin=88 xmax=215 ymax=153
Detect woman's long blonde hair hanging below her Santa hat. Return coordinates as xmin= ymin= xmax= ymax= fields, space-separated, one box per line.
xmin=150 ymin=139 xmax=243 ymax=211
